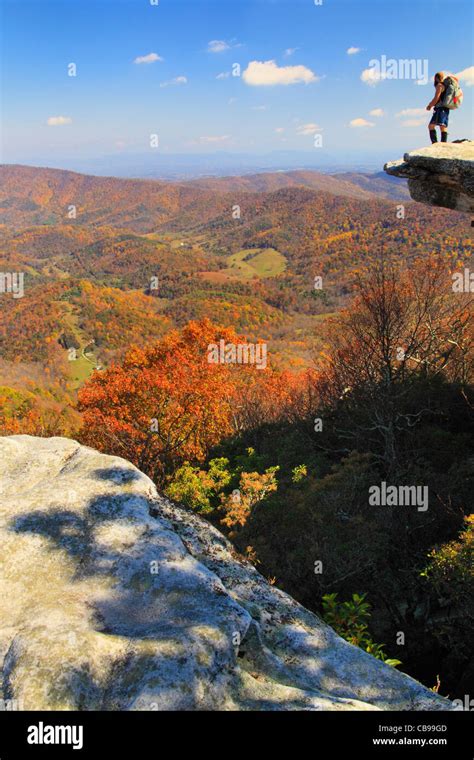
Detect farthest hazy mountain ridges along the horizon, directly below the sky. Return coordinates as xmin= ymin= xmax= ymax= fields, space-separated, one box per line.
xmin=0 ymin=164 xmax=409 ymax=232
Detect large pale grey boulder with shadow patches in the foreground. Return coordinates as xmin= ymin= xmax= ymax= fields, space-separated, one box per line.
xmin=0 ymin=436 xmax=452 ymax=710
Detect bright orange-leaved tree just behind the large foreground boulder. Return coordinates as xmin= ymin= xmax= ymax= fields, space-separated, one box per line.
xmin=79 ymin=320 xmax=288 ymax=484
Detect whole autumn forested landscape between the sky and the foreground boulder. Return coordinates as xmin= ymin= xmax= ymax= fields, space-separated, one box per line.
xmin=0 ymin=167 xmax=474 ymax=698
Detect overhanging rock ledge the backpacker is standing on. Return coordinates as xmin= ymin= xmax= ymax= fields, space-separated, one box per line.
xmin=384 ymin=140 xmax=474 ymax=213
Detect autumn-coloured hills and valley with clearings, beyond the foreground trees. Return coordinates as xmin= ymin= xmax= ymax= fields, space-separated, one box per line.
xmin=0 ymin=165 xmax=470 ymax=374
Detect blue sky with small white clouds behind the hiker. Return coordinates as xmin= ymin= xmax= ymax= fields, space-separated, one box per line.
xmin=1 ymin=0 xmax=474 ymax=168
